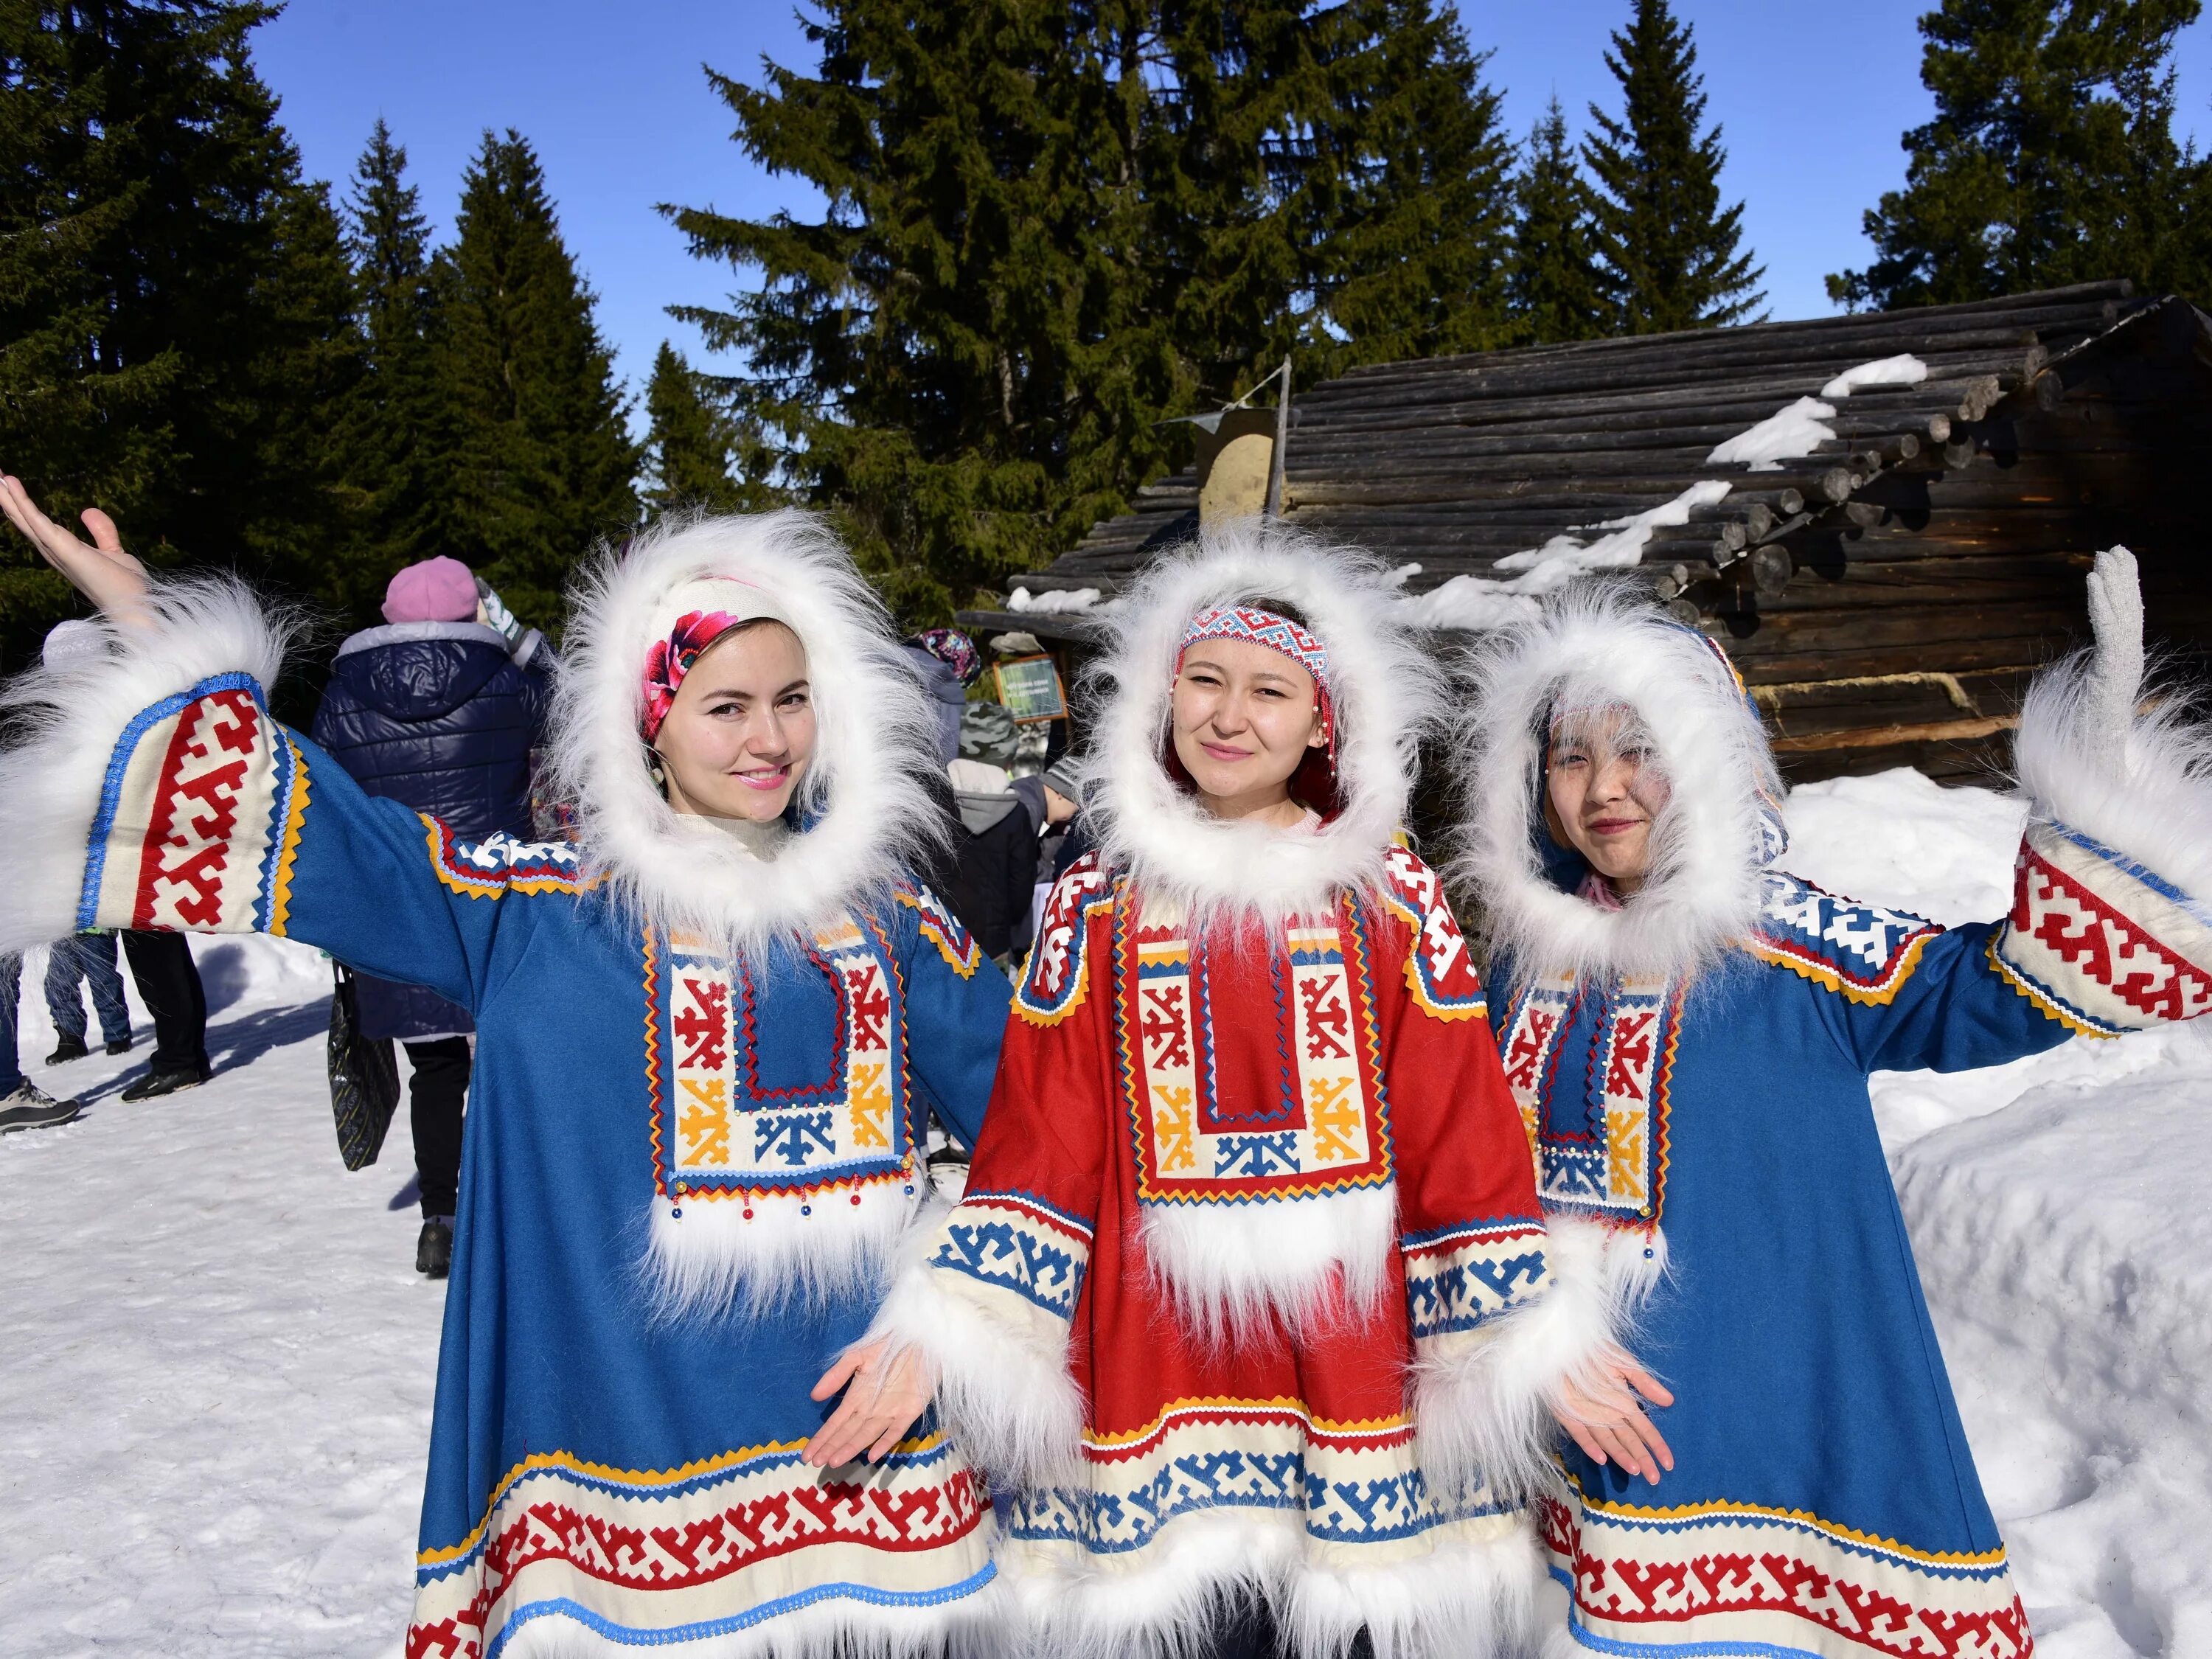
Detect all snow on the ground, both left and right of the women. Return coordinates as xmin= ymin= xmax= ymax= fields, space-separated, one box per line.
xmin=0 ymin=772 xmax=2212 ymax=1659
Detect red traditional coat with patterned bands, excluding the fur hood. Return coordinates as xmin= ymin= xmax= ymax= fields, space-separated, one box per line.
xmin=894 ymin=847 xmax=1546 ymax=1650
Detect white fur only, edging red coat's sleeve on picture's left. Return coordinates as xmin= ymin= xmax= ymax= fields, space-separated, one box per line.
xmin=860 ymin=1228 xmax=1084 ymax=1486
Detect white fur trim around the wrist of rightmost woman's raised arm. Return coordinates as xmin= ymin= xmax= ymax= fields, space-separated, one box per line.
xmin=2013 ymin=575 xmax=2212 ymax=920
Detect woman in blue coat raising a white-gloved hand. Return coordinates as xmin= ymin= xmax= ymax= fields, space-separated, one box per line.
xmin=1462 ymin=551 xmax=2212 ymax=1659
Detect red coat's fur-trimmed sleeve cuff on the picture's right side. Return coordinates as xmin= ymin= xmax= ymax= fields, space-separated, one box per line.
xmin=1407 ymin=1219 xmax=1663 ymax=1500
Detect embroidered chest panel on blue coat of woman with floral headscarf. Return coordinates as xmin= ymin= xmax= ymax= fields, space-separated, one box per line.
xmin=646 ymin=920 xmax=914 ymax=1201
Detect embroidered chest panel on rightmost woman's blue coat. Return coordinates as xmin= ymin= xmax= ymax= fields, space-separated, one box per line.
xmin=1500 ymin=975 xmax=1681 ymax=1228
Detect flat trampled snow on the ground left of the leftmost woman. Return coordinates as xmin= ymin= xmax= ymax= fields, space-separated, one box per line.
xmin=0 ymin=938 xmax=445 ymax=1659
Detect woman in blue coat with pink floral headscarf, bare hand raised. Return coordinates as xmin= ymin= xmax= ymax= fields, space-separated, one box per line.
xmin=0 ymin=478 xmax=1011 ymax=1659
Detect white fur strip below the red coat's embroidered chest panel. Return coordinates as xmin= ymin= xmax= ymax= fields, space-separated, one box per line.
xmin=1141 ymin=1186 xmax=1398 ymax=1347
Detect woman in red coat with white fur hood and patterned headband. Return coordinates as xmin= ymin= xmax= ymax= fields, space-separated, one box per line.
xmin=849 ymin=520 xmax=1610 ymax=1659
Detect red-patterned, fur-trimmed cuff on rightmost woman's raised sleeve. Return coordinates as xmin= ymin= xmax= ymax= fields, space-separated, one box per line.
xmin=1991 ymin=653 xmax=2212 ymax=1035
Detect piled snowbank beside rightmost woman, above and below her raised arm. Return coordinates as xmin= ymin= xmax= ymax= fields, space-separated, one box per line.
xmin=1783 ymin=772 xmax=2212 ymax=1659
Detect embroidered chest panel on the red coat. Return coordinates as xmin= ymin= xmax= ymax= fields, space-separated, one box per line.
xmin=1113 ymin=889 xmax=1391 ymax=1203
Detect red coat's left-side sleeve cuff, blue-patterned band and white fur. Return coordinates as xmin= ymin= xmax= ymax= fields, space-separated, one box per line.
xmin=863 ymin=1192 xmax=1091 ymax=1484
